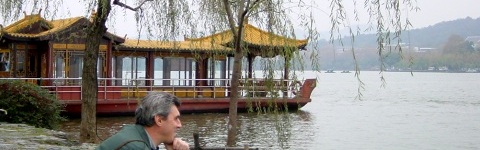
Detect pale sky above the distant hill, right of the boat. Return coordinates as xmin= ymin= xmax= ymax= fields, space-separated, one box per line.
xmin=306 ymin=0 xmax=480 ymax=39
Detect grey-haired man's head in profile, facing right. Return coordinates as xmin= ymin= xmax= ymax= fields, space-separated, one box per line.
xmin=135 ymin=92 xmax=182 ymax=144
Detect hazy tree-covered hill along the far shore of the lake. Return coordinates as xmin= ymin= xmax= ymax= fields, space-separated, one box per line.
xmin=302 ymin=17 xmax=480 ymax=72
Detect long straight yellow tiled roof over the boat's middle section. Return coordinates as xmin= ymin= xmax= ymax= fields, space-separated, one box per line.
xmin=119 ymin=39 xmax=231 ymax=51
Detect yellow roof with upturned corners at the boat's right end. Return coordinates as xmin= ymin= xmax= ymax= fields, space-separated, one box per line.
xmin=185 ymin=24 xmax=308 ymax=47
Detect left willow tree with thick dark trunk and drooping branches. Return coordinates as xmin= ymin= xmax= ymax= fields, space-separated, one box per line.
xmin=80 ymin=0 xmax=193 ymax=143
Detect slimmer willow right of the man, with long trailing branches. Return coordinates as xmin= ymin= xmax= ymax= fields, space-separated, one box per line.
xmin=195 ymin=0 xmax=415 ymax=146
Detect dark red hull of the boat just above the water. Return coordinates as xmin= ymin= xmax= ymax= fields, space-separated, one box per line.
xmin=62 ymin=97 xmax=311 ymax=116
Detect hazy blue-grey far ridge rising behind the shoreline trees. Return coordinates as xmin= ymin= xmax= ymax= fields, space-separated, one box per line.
xmin=319 ymin=17 xmax=480 ymax=48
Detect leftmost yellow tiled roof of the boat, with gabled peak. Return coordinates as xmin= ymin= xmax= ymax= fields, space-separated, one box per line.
xmin=4 ymin=15 xmax=84 ymax=38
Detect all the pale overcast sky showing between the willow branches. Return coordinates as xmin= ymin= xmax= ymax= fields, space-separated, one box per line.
xmin=0 ymin=0 xmax=480 ymax=37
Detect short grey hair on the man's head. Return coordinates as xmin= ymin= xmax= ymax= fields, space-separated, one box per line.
xmin=135 ymin=92 xmax=181 ymax=127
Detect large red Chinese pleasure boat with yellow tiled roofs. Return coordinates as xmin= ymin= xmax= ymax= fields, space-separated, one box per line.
xmin=0 ymin=15 xmax=317 ymax=115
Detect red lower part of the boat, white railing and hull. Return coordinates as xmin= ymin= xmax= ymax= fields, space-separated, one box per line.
xmin=0 ymin=78 xmax=316 ymax=115
